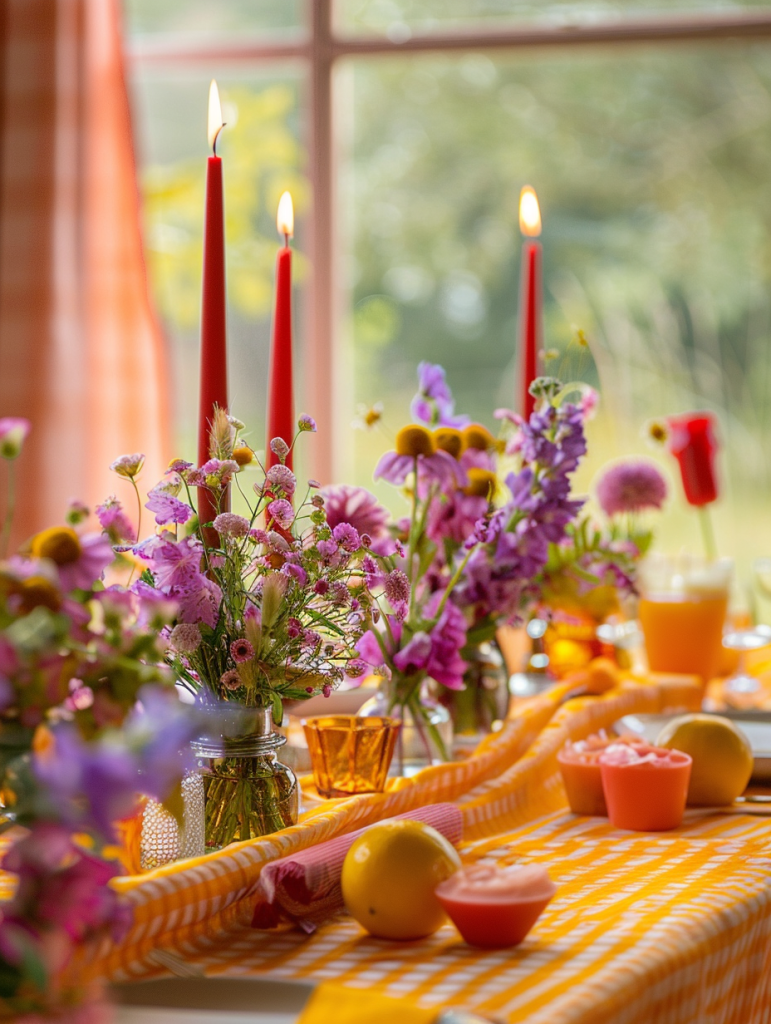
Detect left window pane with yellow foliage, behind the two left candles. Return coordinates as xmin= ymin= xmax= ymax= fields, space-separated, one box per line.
xmin=127 ymin=67 xmax=309 ymax=473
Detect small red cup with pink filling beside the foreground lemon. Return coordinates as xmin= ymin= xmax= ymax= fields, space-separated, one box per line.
xmin=435 ymin=864 xmax=557 ymax=949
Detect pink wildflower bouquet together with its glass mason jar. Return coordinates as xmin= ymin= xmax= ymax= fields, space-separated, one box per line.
xmin=111 ymin=410 xmax=399 ymax=848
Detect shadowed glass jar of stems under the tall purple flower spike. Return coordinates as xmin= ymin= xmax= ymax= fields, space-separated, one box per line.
xmin=441 ymin=641 xmax=509 ymax=746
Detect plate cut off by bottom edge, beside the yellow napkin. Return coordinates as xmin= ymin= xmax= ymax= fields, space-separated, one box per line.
xmin=110 ymin=977 xmax=315 ymax=1024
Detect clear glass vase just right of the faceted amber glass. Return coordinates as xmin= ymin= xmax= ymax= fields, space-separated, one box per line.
xmin=358 ymin=680 xmax=453 ymax=776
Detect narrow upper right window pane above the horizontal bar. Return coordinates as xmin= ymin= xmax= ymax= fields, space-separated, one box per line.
xmin=336 ymin=0 xmax=769 ymax=35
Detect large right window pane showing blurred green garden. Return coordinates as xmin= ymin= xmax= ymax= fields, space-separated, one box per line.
xmin=338 ymin=45 xmax=771 ymax=577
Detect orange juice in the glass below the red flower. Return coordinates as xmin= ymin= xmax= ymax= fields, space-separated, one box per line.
xmin=638 ymin=591 xmax=728 ymax=685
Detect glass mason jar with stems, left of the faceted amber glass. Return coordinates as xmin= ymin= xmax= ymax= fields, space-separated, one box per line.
xmin=192 ymin=708 xmax=299 ymax=850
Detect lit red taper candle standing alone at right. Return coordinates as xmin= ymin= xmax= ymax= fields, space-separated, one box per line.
xmin=519 ymin=185 xmax=544 ymax=418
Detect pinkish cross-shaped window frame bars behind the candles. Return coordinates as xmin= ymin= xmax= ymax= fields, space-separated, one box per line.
xmin=127 ymin=0 xmax=771 ymax=483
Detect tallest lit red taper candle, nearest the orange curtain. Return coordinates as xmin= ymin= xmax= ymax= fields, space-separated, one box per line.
xmin=198 ymin=81 xmax=227 ymax=523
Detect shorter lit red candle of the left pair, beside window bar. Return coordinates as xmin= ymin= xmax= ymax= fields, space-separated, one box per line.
xmin=265 ymin=193 xmax=295 ymax=468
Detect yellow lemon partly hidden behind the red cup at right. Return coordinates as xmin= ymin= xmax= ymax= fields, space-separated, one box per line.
xmin=656 ymin=715 xmax=754 ymax=807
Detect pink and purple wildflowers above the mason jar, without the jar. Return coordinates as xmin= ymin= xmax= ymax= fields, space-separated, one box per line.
xmin=115 ymin=411 xmax=382 ymax=723
